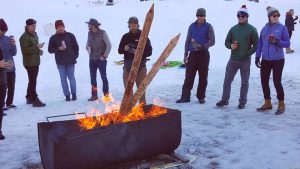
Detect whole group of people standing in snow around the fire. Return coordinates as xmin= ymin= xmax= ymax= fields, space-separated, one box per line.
xmin=0 ymin=5 xmax=298 ymax=140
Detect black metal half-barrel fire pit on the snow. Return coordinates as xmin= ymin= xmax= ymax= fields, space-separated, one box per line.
xmin=38 ymin=105 xmax=181 ymax=169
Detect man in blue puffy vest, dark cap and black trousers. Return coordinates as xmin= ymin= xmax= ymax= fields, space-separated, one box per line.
xmin=176 ymin=8 xmax=215 ymax=104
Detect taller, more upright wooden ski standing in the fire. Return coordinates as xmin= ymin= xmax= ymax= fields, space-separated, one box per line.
xmin=120 ymin=4 xmax=154 ymax=115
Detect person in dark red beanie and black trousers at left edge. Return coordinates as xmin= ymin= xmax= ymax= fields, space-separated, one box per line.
xmin=0 ymin=19 xmax=17 ymax=110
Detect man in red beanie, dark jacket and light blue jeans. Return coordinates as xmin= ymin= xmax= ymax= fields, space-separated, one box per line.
xmin=48 ymin=20 xmax=79 ymax=101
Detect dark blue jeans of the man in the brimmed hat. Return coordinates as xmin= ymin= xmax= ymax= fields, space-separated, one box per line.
xmin=89 ymin=59 xmax=109 ymax=96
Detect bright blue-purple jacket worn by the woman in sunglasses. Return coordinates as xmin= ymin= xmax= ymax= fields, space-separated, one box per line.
xmin=256 ymin=22 xmax=290 ymax=61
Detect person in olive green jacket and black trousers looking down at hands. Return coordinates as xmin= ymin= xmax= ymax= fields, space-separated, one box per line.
xmin=20 ymin=19 xmax=46 ymax=107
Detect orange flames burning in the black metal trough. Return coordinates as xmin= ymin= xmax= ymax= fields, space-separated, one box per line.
xmin=77 ymin=94 xmax=167 ymax=130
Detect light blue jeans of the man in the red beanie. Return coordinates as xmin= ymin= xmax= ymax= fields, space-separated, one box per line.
xmin=57 ymin=64 xmax=76 ymax=96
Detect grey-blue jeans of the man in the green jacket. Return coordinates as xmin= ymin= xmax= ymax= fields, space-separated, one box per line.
xmin=222 ymin=59 xmax=251 ymax=104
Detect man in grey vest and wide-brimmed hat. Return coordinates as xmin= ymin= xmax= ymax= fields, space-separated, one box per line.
xmin=86 ymin=18 xmax=111 ymax=101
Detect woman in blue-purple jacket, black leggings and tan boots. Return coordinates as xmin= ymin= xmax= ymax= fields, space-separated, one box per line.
xmin=255 ymin=7 xmax=290 ymax=115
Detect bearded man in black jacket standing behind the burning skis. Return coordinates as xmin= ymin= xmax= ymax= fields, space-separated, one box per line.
xmin=118 ymin=16 xmax=152 ymax=104
